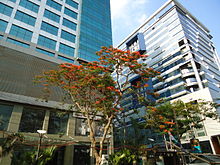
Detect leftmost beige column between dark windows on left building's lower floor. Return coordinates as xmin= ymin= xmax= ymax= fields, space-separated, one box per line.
xmin=7 ymin=105 xmax=23 ymax=132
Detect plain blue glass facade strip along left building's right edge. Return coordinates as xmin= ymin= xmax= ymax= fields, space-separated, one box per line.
xmin=79 ymin=0 xmax=112 ymax=61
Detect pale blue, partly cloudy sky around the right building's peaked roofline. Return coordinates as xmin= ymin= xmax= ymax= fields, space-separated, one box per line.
xmin=110 ymin=0 xmax=220 ymax=53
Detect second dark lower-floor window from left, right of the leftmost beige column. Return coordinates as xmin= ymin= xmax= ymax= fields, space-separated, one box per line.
xmin=18 ymin=108 xmax=45 ymax=133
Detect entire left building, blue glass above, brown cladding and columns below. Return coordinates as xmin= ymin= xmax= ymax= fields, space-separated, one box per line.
xmin=0 ymin=0 xmax=112 ymax=165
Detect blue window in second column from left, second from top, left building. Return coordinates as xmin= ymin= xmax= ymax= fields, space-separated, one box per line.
xmin=15 ymin=11 xmax=36 ymax=26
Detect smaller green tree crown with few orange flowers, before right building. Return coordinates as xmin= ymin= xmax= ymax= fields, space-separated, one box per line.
xmin=146 ymin=100 xmax=217 ymax=141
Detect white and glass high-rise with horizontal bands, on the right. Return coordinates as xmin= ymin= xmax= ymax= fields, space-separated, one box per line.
xmin=118 ymin=0 xmax=220 ymax=152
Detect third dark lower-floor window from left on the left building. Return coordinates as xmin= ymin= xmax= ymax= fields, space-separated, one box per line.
xmin=48 ymin=112 xmax=69 ymax=134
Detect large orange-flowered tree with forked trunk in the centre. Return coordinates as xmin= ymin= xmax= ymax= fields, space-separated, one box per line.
xmin=37 ymin=47 xmax=158 ymax=165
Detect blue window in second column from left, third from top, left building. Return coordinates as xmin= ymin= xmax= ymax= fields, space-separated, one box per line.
xmin=9 ymin=25 xmax=33 ymax=41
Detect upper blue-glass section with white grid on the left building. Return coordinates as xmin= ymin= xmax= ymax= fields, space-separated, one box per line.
xmin=0 ymin=0 xmax=112 ymax=63
